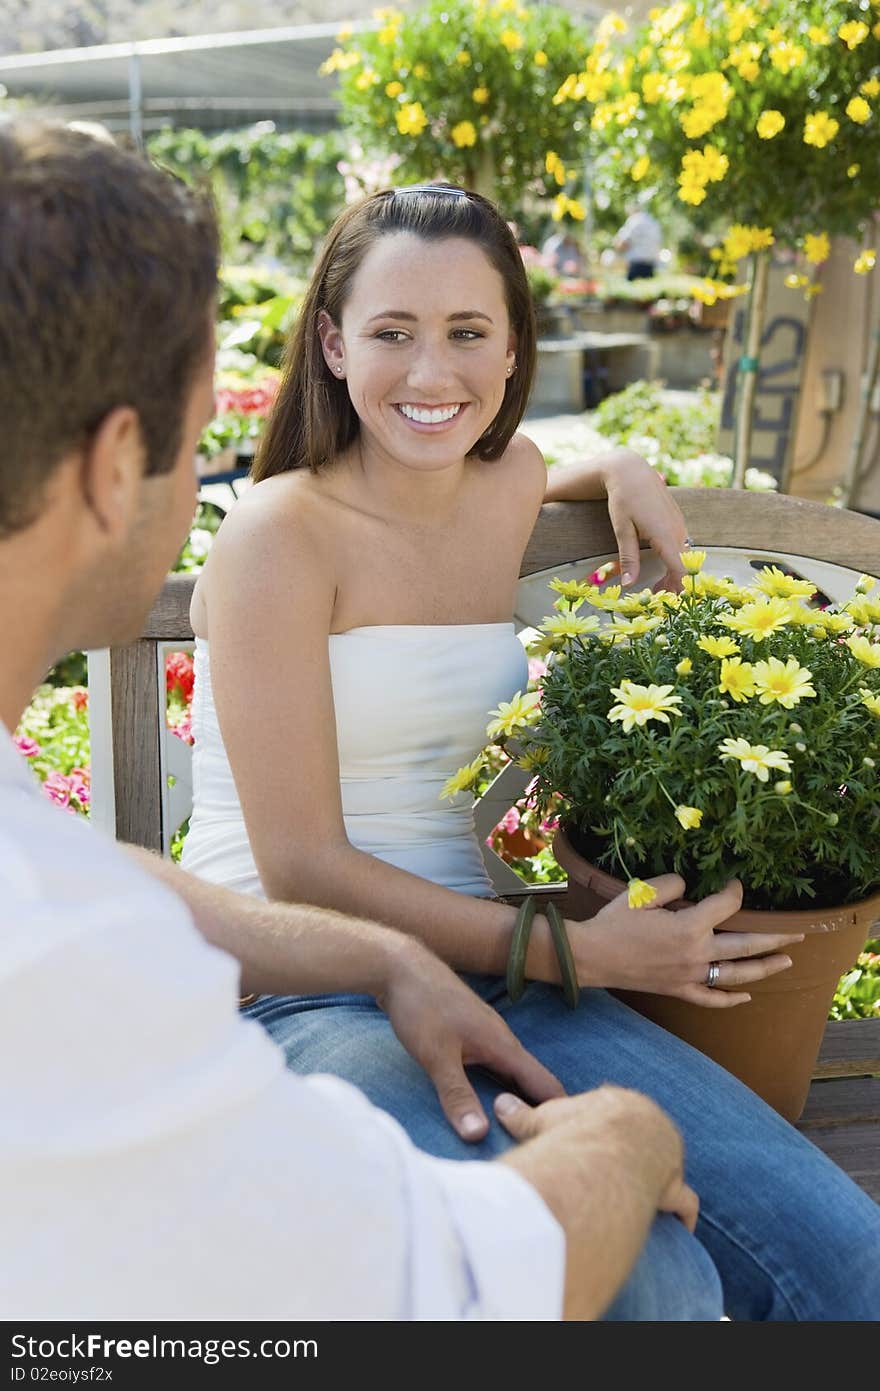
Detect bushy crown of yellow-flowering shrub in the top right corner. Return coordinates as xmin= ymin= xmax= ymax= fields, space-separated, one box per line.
xmin=572 ymin=0 xmax=880 ymax=245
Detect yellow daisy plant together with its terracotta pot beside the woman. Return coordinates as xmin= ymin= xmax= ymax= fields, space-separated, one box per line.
xmin=453 ymin=551 xmax=880 ymax=1120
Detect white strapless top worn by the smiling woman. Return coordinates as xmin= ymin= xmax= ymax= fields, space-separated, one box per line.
xmin=182 ymin=623 xmax=528 ymax=897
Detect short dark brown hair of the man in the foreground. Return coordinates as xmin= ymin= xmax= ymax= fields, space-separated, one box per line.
xmin=0 ymin=120 xmax=218 ymax=538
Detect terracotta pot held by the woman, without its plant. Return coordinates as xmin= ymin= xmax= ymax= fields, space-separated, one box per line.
xmin=553 ymin=829 xmax=880 ymax=1123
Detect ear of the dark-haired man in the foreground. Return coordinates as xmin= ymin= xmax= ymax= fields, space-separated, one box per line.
xmin=79 ymin=406 xmax=145 ymax=541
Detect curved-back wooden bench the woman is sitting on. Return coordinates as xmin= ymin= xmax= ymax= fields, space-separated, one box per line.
xmin=89 ymin=488 xmax=880 ymax=1200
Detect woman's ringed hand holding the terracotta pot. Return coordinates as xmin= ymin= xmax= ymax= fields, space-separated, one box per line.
xmin=567 ymin=874 xmax=804 ymax=1010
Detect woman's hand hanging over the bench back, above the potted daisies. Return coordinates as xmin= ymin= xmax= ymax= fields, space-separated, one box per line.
xmin=601 ymin=449 xmax=687 ymax=591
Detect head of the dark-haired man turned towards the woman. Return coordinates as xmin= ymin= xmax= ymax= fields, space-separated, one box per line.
xmin=0 ymin=121 xmax=218 ymax=648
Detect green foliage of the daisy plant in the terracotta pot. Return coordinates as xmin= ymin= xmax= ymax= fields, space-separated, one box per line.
xmin=525 ymin=572 xmax=880 ymax=908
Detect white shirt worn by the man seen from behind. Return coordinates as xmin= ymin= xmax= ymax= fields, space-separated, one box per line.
xmin=0 ymin=725 xmax=564 ymax=1320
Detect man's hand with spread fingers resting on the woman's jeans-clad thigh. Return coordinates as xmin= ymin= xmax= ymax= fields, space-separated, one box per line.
xmin=377 ymin=939 xmax=564 ymax=1142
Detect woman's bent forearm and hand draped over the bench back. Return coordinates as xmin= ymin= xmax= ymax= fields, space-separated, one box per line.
xmin=544 ymin=447 xmax=687 ymax=590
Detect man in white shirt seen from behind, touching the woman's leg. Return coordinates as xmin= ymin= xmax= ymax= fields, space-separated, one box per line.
xmin=0 ymin=122 xmax=699 ymax=1320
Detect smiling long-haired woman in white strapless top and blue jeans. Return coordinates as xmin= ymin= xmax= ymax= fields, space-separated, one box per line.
xmin=185 ymin=186 xmax=880 ymax=1320
